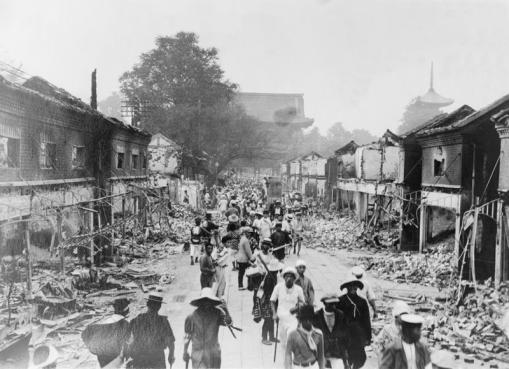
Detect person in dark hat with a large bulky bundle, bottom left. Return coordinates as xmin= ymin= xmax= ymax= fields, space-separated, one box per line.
xmin=81 ymin=298 xmax=131 ymax=368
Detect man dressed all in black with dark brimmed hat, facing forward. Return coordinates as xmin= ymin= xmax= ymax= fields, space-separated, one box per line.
xmin=337 ymin=276 xmax=371 ymax=369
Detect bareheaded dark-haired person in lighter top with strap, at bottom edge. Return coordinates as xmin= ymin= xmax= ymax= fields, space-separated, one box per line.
xmin=285 ymin=305 xmax=325 ymax=369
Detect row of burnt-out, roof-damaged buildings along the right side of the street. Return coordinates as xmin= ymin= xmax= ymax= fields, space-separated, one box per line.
xmin=325 ymin=96 xmax=509 ymax=284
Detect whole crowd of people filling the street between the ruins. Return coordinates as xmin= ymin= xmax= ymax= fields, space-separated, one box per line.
xmin=83 ymin=177 xmax=456 ymax=369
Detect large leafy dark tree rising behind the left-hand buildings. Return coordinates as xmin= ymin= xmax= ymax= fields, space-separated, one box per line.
xmin=120 ymin=32 xmax=267 ymax=179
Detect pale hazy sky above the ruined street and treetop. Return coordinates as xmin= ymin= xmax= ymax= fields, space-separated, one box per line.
xmin=0 ymin=0 xmax=509 ymax=135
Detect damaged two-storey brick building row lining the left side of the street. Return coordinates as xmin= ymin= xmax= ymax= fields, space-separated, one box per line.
xmin=0 ymin=77 xmax=150 ymax=262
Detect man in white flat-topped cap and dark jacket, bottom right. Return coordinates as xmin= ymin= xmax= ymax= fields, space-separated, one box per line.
xmin=379 ymin=314 xmax=431 ymax=369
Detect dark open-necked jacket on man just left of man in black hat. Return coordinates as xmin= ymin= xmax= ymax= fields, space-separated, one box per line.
xmin=313 ymin=309 xmax=348 ymax=358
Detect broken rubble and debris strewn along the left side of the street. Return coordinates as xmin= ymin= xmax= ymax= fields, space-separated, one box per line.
xmin=0 ymin=200 xmax=198 ymax=367
